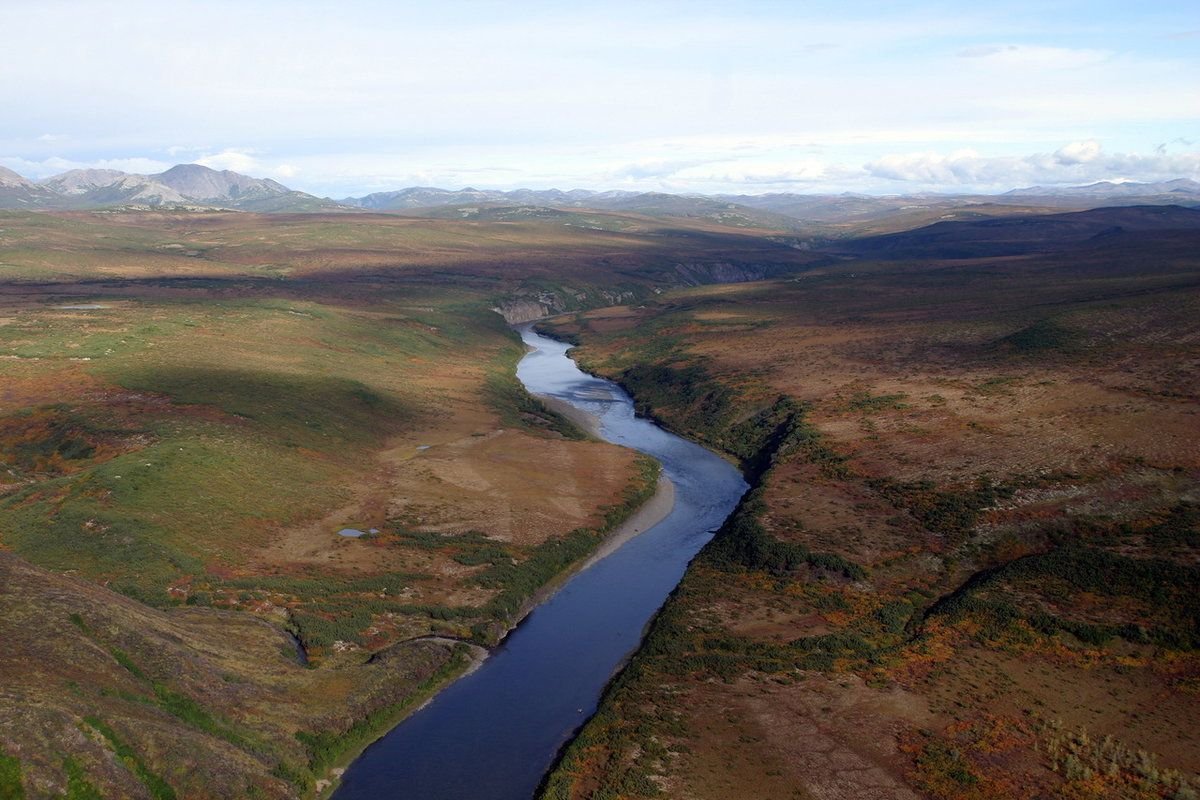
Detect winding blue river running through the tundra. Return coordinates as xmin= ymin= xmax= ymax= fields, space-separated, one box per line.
xmin=334 ymin=326 xmax=746 ymax=800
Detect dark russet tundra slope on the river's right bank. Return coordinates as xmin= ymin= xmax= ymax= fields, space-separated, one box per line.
xmin=545 ymin=235 xmax=1200 ymax=798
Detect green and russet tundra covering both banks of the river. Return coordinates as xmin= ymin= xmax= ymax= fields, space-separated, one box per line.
xmin=0 ymin=210 xmax=1200 ymax=798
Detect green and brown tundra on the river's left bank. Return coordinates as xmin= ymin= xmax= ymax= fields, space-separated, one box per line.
xmin=0 ymin=211 xmax=804 ymax=798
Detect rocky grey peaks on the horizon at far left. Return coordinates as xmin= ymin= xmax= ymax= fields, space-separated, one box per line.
xmin=0 ymin=164 xmax=346 ymax=212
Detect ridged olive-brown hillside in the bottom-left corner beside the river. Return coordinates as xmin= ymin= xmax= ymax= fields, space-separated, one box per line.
xmin=0 ymin=552 xmax=468 ymax=800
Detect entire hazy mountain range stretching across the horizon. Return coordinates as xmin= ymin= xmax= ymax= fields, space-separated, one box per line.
xmin=0 ymin=164 xmax=1200 ymax=227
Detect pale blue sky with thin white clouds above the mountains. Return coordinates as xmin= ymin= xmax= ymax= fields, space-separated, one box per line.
xmin=0 ymin=0 xmax=1200 ymax=198
